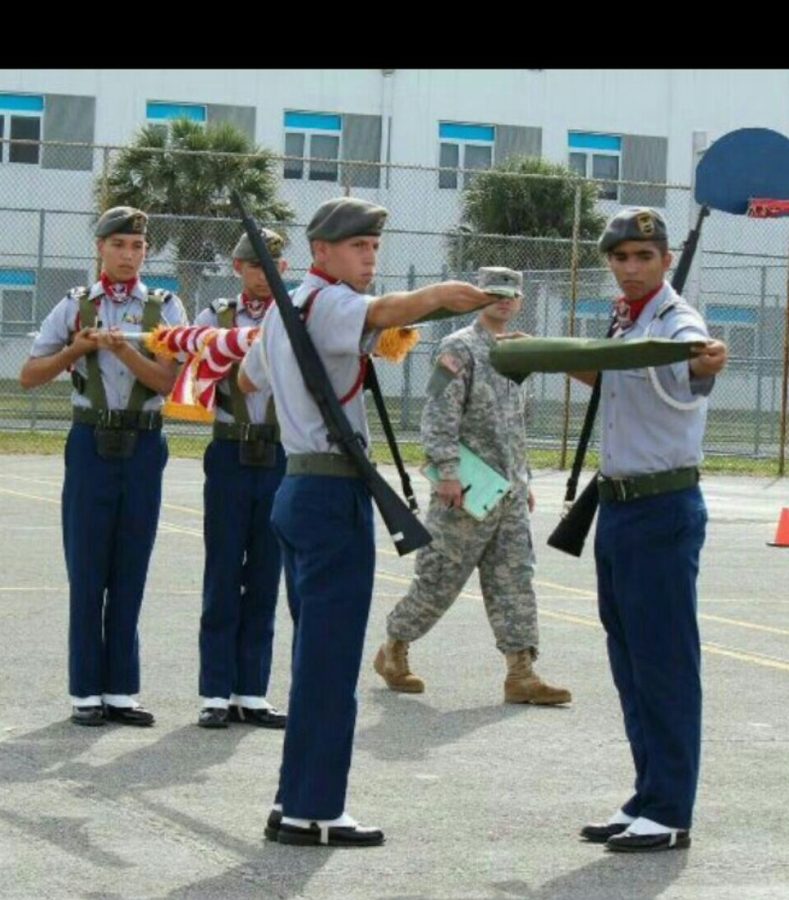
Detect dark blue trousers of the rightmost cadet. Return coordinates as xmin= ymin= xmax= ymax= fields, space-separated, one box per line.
xmin=595 ymin=487 xmax=707 ymax=828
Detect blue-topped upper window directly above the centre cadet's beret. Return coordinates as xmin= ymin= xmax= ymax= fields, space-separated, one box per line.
xmin=284 ymin=110 xmax=342 ymax=181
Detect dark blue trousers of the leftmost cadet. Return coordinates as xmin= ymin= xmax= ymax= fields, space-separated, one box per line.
xmin=62 ymin=424 xmax=168 ymax=697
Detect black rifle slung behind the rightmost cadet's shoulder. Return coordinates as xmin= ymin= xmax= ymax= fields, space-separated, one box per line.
xmin=547 ymin=205 xmax=710 ymax=557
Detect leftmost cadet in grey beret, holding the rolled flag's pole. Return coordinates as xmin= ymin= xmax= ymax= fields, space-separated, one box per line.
xmin=20 ymin=206 xmax=186 ymax=725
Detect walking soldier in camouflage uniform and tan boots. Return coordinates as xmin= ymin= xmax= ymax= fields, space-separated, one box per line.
xmin=374 ymin=268 xmax=572 ymax=705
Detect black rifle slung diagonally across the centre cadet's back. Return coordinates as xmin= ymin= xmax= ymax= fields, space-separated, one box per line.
xmin=232 ymin=191 xmax=433 ymax=556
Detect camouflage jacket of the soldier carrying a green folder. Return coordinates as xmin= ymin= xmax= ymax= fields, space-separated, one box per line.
xmin=422 ymin=320 xmax=529 ymax=482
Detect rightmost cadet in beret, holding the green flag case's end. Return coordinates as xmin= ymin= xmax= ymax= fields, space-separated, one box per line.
xmin=581 ymin=207 xmax=727 ymax=853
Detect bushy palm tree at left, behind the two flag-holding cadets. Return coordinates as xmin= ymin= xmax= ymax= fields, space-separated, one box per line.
xmin=95 ymin=119 xmax=293 ymax=304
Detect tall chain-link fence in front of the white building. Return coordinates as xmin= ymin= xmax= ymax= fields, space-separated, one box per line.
xmin=0 ymin=140 xmax=789 ymax=474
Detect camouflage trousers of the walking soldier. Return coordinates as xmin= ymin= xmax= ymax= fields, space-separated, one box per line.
xmin=386 ymin=485 xmax=539 ymax=658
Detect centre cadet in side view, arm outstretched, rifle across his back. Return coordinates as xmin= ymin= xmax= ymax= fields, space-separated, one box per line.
xmin=252 ymin=197 xmax=492 ymax=846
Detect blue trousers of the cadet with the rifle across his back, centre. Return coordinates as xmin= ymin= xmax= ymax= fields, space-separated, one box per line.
xmin=272 ymin=475 xmax=375 ymax=819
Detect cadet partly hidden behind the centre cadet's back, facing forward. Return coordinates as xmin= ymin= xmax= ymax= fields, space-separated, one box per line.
xmin=195 ymin=229 xmax=294 ymax=728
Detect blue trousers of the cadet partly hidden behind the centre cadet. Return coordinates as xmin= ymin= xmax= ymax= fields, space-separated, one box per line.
xmin=199 ymin=440 xmax=292 ymax=698
